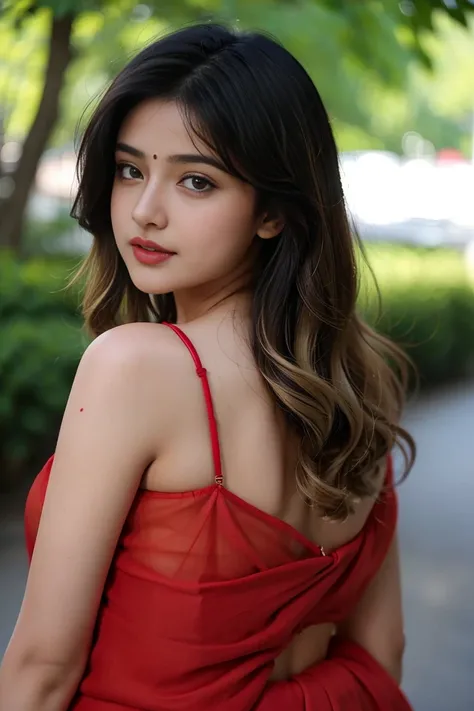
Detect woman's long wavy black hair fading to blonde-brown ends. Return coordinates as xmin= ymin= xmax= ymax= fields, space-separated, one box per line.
xmin=72 ymin=24 xmax=415 ymax=521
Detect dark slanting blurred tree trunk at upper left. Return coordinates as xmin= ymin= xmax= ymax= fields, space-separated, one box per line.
xmin=0 ymin=14 xmax=75 ymax=252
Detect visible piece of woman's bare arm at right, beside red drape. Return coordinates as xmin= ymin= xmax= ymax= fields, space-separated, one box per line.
xmin=338 ymin=536 xmax=405 ymax=682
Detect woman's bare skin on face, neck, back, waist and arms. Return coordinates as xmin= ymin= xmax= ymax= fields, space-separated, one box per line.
xmin=0 ymin=101 xmax=403 ymax=711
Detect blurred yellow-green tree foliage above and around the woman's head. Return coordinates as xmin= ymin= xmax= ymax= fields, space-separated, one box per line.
xmin=0 ymin=0 xmax=474 ymax=157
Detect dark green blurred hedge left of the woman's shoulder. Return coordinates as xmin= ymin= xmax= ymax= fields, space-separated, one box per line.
xmin=0 ymin=254 xmax=86 ymax=487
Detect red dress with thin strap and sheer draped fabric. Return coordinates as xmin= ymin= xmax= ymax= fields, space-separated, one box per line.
xmin=25 ymin=326 xmax=410 ymax=711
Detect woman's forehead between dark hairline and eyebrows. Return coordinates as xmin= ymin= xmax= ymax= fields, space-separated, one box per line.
xmin=118 ymin=99 xmax=204 ymax=153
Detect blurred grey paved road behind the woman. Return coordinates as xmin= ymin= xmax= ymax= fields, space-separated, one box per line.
xmin=0 ymin=383 xmax=474 ymax=711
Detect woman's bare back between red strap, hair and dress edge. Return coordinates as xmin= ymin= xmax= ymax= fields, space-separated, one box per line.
xmin=142 ymin=314 xmax=385 ymax=568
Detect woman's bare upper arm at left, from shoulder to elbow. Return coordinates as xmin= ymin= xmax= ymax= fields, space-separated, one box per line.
xmin=3 ymin=329 xmax=164 ymax=670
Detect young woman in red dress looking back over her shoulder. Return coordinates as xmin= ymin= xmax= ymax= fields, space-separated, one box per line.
xmin=0 ymin=24 xmax=414 ymax=711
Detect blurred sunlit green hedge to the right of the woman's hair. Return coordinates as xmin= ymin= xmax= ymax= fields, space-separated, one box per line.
xmin=361 ymin=245 xmax=474 ymax=388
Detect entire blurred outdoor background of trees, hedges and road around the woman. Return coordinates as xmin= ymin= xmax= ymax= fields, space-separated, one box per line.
xmin=0 ymin=0 xmax=474 ymax=711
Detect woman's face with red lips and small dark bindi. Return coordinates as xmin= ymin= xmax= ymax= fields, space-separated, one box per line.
xmin=111 ymin=100 xmax=272 ymax=295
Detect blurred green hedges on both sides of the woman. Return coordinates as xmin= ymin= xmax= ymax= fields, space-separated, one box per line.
xmin=0 ymin=245 xmax=474 ymax=487
